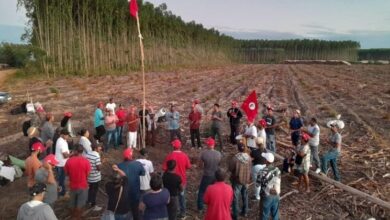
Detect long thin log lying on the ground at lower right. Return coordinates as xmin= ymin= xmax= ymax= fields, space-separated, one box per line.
xmin=275 ymin=141 xmax=390 ymax=210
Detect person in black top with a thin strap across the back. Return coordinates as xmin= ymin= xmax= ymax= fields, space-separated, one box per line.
xmin=106 ymin=165 xmax=130 ymax=219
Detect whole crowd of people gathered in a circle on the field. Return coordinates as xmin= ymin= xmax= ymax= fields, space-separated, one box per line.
xmin=17 ymin=99 xmax=341 ymax=220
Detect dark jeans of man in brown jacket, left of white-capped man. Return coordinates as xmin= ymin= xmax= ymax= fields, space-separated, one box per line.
xmin=232 ymin=183 xmax=248 ymax=220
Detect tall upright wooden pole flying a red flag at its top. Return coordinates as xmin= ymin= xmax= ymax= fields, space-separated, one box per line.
xmin=136 ymin=12 xmax=146 ymax=148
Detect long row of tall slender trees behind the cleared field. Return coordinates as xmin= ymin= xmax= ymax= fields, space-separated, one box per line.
xmin=18 ymin=0 xmax=359 ymax=77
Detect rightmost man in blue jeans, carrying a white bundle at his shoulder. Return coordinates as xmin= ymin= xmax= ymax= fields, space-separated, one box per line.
xmin=321 ymin=123 xmax=342 ymax=181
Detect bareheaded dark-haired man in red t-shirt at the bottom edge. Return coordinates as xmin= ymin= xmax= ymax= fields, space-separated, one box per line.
xmin=203 ymin=169 xmax=233 ymax=220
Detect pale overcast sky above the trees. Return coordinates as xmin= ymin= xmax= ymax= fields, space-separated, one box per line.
xmin=0 ymin=0 xmax=390 ymax=48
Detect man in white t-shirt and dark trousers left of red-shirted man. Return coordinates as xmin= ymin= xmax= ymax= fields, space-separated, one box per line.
xmin=55 ymin=128 xmax=70 ymax=196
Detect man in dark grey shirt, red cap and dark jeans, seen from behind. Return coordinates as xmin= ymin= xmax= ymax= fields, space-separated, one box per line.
xmin=198 ymin=138 xmax=222 ymax=212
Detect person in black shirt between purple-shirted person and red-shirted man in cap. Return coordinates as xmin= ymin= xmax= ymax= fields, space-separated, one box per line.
xmin=163 ymin=160 xmax=183 ymax=220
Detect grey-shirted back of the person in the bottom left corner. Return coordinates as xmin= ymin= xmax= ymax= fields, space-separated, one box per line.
xmin=16 ymin=200 xmax=57 ymax=220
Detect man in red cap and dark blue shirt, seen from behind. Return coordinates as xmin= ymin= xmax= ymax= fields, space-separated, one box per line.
xmin=118 ymin=148 xmax=145 ymax=220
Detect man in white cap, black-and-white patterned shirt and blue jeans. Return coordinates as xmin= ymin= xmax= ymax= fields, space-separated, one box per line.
xmin=256 ymin=153 xmax=281 ymax=220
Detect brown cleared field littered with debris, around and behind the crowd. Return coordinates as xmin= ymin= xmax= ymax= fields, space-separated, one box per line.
xmin=0 ymin=65 xmax=390 ymax=219
